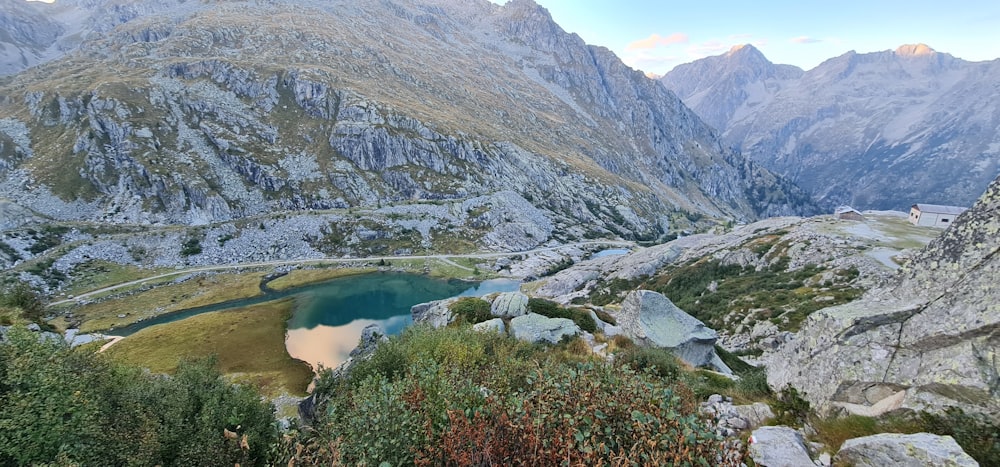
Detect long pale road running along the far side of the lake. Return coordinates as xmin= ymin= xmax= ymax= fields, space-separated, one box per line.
xmin=48 ymin=240 xmax=635 ymax=306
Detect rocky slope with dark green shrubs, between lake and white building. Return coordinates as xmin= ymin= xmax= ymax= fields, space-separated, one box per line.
xmin=533 ymin=208 xmax=940 ymax=354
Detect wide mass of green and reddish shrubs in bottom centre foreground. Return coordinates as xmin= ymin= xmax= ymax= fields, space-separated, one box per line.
xmin=296 ymin=327 xmax=736 ymax=465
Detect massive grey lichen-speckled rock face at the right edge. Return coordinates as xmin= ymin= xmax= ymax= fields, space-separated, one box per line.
xmin=768 ymin=178 xmax=1000 ymax=418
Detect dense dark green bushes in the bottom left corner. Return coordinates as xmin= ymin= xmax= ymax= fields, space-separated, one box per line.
xmin=0 ymin=327 xmax=278 ymax=465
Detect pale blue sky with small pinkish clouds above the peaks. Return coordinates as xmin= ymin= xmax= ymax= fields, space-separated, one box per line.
xmin=492 ymin=0 xmax=1000 ymax=75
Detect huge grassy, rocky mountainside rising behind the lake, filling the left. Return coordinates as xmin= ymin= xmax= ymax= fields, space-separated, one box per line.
xmin=0 ymin=0 xmax=808 ymax=242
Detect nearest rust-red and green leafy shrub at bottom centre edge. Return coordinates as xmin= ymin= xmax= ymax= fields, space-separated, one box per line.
xmin=419 ymin=364 xmax=721 ymax=465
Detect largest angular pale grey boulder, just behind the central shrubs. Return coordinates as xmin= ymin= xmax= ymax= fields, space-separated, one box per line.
xmin=615 ymin=290 xmax=732 ymax=374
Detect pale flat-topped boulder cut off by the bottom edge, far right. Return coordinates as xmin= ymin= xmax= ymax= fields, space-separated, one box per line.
xmin=834 ymin=433 xmax=979 ymax=467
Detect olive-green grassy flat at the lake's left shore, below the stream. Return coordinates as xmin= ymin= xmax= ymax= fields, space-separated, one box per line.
xmin=106 ymin=299 xmax=313 ymax=396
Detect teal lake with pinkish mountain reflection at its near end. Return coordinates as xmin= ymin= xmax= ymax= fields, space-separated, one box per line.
xmin=285 ymin=273 xmax=520 ymax=368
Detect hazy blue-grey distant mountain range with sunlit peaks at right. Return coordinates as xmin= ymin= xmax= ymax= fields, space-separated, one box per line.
xmin=661 ymin=44 xmax=1000 ymax=210
